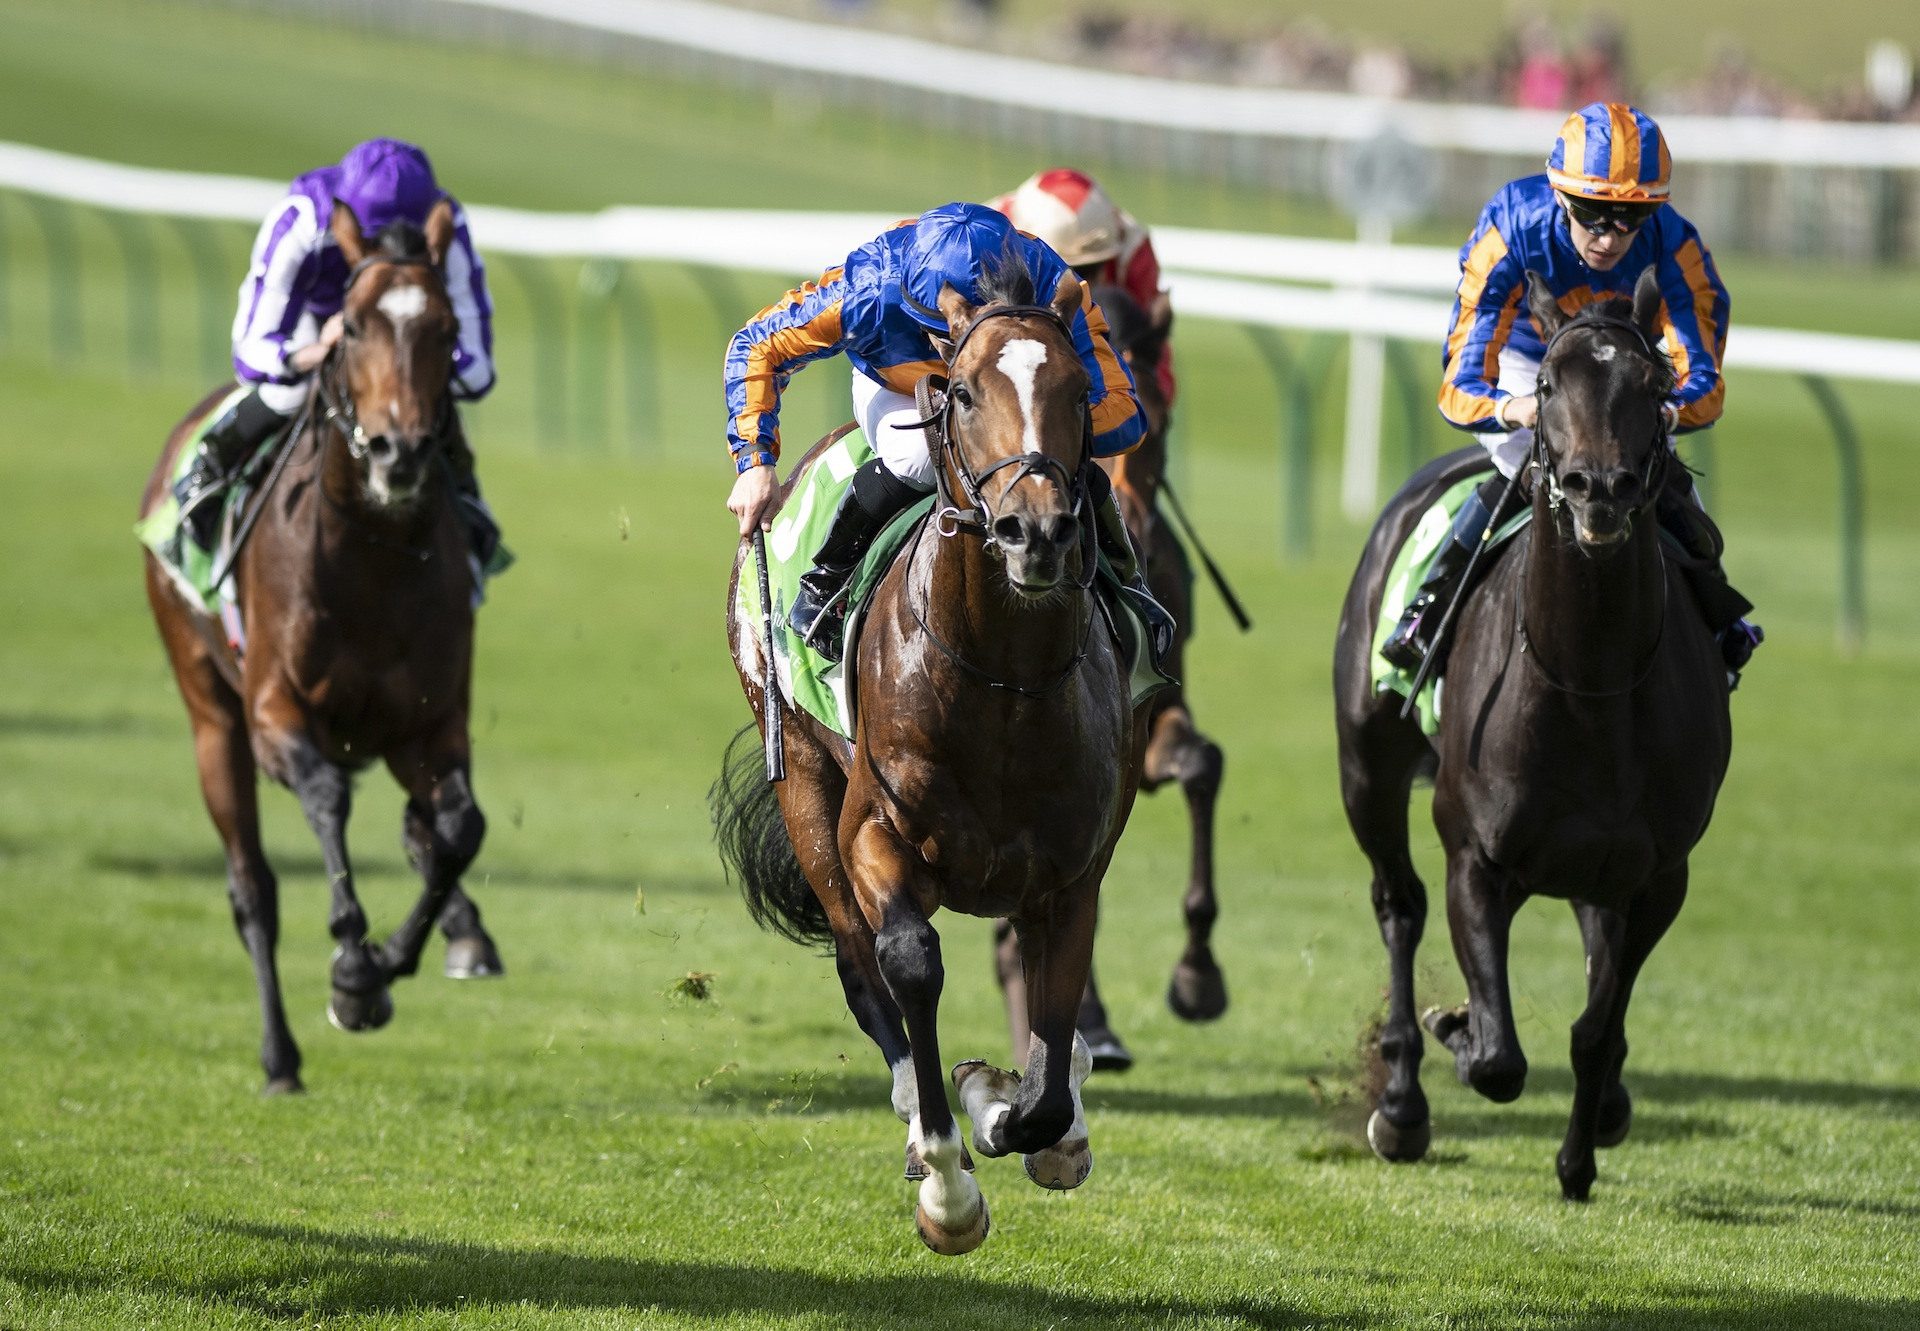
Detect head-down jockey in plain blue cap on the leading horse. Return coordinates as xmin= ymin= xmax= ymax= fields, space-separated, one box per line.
xmin=726 ymin=204 xmax=1173 ymax=659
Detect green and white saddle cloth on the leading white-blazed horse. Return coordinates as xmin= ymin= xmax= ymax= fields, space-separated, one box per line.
xmin=733 ymin=430 xmax=1171 ymax=739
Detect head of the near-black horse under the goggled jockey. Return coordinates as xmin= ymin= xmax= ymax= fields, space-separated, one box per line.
xmin=1528 ymin=267 xmax=1674 ymax=553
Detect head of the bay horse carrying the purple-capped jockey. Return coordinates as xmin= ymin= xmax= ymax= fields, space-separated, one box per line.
xmin=328 ymin=200 xmax=459 ymax=507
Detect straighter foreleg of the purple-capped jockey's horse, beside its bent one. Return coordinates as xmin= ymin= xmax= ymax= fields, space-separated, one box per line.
xmin=255 ymin=710 xmax=394 ymax=1031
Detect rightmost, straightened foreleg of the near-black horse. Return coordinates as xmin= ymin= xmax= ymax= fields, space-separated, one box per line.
xmin=1555 ymin=864 xmax=1688 ymax=1202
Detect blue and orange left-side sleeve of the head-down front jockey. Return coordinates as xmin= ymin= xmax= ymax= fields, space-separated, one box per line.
xmin=726 ymin=267 xmax=847 ymax=472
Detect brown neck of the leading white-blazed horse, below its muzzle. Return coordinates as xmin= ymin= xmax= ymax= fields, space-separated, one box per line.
xmin=906 ymin=522 xmax=1091 ymax=686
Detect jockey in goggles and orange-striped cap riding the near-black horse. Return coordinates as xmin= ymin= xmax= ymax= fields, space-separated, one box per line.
xmin=1380 ymin=102 xmax=1761 ymax=670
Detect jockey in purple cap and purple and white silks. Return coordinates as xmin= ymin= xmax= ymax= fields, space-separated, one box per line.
xmin=179 ymin=138 xmax=497 ymax=563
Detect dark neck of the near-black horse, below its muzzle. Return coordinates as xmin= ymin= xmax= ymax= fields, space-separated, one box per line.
xmin=1521 ymin=496 xmax=1667 ymax=693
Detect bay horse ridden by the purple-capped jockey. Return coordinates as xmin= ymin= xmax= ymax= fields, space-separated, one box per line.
xmin=140 ymin=202 xmax=501 ymax=1093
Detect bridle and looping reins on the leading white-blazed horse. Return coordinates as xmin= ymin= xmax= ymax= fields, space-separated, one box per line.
xmin=897 ymin=305 xmax=1098 ymax=699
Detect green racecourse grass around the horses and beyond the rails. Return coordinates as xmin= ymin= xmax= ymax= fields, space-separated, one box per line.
xmin=0 ymin=0 xmax=1920 ymax=1331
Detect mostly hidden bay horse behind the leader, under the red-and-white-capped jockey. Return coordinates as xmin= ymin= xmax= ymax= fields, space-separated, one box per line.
xmin=996 ymin=282 xmax=1227 ymax=1072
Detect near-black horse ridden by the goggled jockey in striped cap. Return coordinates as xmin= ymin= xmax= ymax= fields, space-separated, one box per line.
xmin=1334 ymin=269 xmax=1732 ymax=1200
